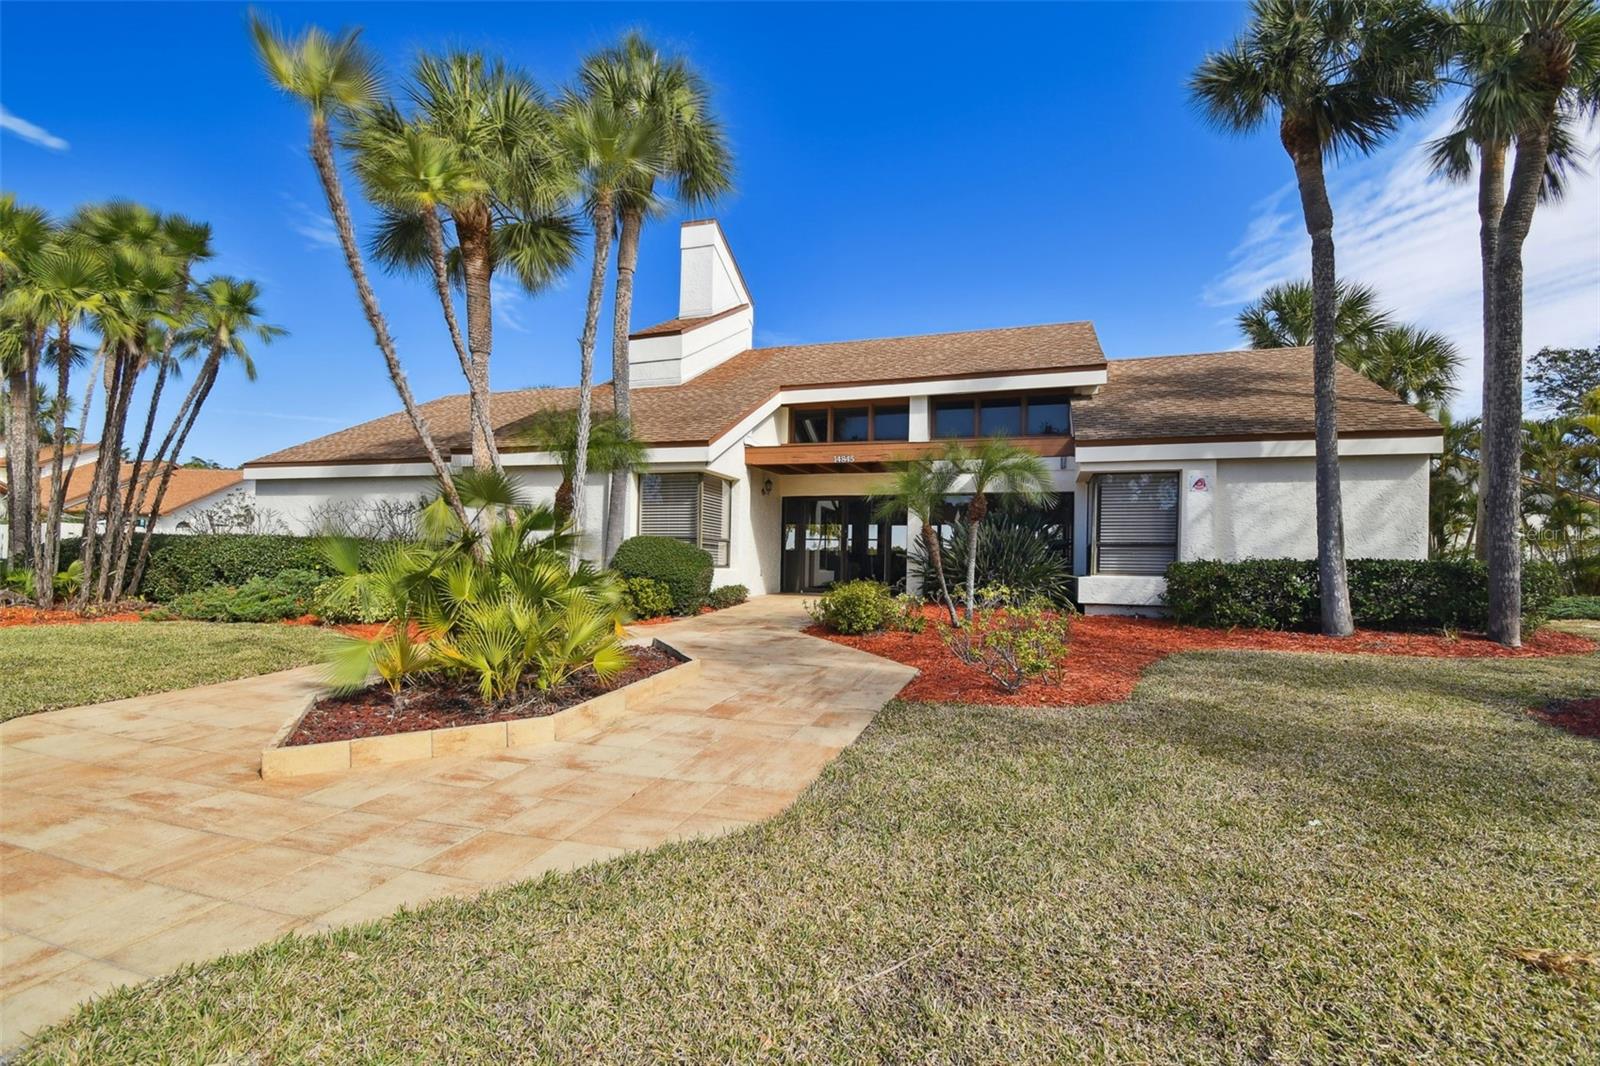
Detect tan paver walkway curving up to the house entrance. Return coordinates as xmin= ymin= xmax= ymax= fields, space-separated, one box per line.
xmin=0 ymin=597 xmax=914 ymax=1048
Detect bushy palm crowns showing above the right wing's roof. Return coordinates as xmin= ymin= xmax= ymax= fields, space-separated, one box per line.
xmin=1237 ymin=282 xmax=1461 ymax=413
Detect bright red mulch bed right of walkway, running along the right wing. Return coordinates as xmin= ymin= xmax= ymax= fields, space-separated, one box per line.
xmin=806 ymin=608 xmax=1600 ymax=707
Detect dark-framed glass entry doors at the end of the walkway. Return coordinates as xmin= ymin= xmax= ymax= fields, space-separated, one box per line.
xmin=782 ymin=496 xmax=907 ymax=592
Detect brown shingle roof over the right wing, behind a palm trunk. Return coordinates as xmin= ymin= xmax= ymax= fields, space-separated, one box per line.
xmin=1072 ymin=347 xmax=1440 ymax=445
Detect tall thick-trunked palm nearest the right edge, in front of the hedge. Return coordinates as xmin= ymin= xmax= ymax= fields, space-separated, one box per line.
xmin=1434 ymin=0 xmax=1600 ymax=647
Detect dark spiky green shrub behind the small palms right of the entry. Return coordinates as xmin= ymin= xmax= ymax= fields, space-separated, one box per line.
xmin=910 ymin=511 xmax=1072 ymax=603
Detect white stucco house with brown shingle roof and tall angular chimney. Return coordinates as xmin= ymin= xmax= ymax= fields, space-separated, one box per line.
xmin=245 ymin=221 xmax=1442 ymax=611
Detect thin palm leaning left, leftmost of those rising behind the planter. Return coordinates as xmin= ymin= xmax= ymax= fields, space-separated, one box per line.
xmin=246 ymin=13 xmax=467 ymax=528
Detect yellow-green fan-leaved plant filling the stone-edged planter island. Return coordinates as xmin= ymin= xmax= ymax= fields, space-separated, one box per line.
xmin=323 ymin=469 xmax=629 ymax=704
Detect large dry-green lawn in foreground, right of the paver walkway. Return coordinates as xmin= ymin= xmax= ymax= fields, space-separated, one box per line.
xmin=19 ymin=653 xmax=1600 ymax=1063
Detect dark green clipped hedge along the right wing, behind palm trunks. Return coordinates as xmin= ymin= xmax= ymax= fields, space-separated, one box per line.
xmin=1166 ymin=559 xmax=1560 ymax=632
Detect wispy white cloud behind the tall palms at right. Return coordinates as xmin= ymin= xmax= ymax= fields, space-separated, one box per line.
xmin=1202 ymin=122 xmax=1600 ymax=413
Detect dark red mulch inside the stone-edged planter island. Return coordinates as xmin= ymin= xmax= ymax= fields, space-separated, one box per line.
xmin=283 ymin=648 xmax=682 ymax=747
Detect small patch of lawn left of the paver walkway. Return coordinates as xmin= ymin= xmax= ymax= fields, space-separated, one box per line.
xmin=0 ymin=623 xmax=333 ymax=722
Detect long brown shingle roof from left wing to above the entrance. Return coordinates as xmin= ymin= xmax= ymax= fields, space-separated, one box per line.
xmin=250 ymin=322 xmax=1106 ymax=466
